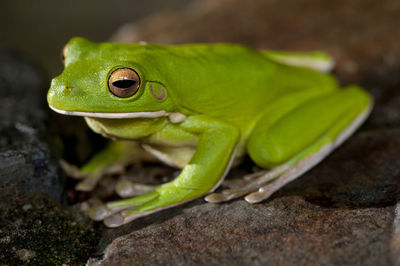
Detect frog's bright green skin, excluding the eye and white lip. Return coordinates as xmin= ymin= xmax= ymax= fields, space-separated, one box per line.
xmin=47 ymin=38 xmax=372 ymax=227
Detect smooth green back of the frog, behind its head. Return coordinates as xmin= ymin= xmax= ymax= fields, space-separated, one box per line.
xmin=149 ymin=44 xmax=336 ymax=130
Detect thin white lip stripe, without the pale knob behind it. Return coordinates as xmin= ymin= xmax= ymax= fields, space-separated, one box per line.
xmin=49 ymin=105 xmax=170 ymax=119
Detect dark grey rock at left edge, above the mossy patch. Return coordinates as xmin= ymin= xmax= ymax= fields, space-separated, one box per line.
xmin=0 ymin=51 xmax=63 ymax=208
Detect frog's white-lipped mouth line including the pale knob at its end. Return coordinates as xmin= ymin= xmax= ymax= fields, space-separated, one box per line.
xmin=49 ymin=105 xmax=186 ymax=123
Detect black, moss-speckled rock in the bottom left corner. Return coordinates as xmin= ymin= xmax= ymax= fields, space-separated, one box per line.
xmin=0 ymin=198 xmax=100 ymax=265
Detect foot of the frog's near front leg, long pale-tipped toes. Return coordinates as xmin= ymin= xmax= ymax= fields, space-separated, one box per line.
xmin=89 ymin=183 xmax=198 ymax=227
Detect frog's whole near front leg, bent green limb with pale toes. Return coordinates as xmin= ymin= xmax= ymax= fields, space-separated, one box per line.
xmin=90 ymin=116 xmax=239 ymax=227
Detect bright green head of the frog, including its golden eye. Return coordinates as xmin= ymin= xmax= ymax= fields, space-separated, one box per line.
xmin=47 ymin=38 xmax=176 ymax=118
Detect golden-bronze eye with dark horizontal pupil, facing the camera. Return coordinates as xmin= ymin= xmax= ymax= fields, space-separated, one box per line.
xmin=108 ymin=68 xmax=140 ymax=98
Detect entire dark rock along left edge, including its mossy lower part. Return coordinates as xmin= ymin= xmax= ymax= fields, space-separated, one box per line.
xmin=0 ymin=50 xmax=100 ymax=265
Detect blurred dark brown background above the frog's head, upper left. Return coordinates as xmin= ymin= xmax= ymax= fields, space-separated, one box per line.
xmin=0 ymin=0 xmax=192 ymax=77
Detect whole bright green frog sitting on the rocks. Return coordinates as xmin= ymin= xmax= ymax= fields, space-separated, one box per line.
xmin=47 ymin=37 xmax=373 ymax=227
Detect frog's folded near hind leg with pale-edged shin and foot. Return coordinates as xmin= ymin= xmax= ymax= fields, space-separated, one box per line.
xmin=206 ymin=86 xmax=372 ymax=203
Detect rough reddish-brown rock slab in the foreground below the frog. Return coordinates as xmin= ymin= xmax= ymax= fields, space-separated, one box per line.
xmin=94 ymin=200 xmax=392 ymax=265
